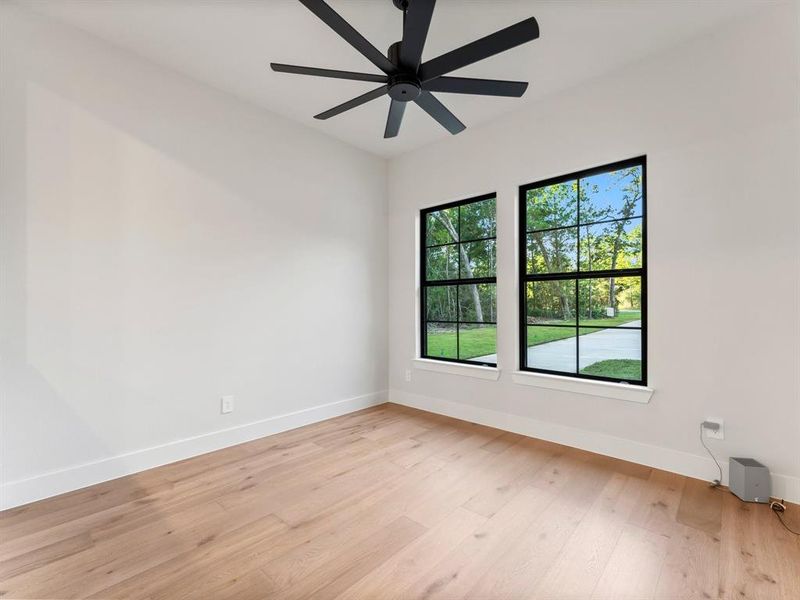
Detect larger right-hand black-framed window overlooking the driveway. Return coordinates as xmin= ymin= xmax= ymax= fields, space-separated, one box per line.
xmin=519 ymin=157 xmax=647 ymax=385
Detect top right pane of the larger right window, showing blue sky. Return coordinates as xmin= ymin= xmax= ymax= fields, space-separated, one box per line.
xmin=581 ymin=166 xmax=642 ymax=223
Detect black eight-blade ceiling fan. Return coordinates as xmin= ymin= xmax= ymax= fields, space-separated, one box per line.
xmin=270 ymin=0 xmax=539 ymax=138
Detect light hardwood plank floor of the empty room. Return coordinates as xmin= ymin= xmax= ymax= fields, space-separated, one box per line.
xmin=0 ymin=404 xmax=800 ymax=600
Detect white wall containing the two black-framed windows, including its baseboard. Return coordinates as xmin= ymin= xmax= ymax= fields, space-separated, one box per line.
xmin=389 ymin=6 xmax=800 ymax=501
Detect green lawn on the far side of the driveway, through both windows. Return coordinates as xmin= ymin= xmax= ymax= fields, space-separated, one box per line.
xmin=428 ymin=311 xmax=640 ymax=366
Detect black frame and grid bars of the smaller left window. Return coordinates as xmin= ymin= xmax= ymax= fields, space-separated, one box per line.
xmin=419 ymin=192 xmax=497 ymax=367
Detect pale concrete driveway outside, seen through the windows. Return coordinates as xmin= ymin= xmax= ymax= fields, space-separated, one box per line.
xmin=473 ymin=321 xmax=642 ymax=373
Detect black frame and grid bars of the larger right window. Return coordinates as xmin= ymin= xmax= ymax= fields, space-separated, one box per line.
xmin=518 ymin=155 xmax=648 ymax=386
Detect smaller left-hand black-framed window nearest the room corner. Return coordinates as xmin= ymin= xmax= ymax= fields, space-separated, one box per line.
xmin=420 ymin=194 xmax=497 ymax=366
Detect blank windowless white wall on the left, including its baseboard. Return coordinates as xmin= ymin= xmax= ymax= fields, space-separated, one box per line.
xmin=0 ymin=2 xmax=387 ymax=506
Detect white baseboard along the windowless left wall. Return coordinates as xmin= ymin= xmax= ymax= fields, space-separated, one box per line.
xmin=0 ymin=390 xmax=387 ymax=510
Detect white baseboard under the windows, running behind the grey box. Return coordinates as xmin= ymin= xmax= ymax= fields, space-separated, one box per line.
xmin=389 ymin=390 xmax=800 ymax=503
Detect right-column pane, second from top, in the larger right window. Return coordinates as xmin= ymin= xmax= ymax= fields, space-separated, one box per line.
xmin=580 ymin=219 xmax=644 ymax=271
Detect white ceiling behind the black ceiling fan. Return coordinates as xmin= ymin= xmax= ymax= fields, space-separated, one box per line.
xmin=21 ymin=0 xmax=777 ymax=156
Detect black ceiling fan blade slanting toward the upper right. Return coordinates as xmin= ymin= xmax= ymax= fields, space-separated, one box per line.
xmin=419 ymin=17 xmax=539 ymax=82
